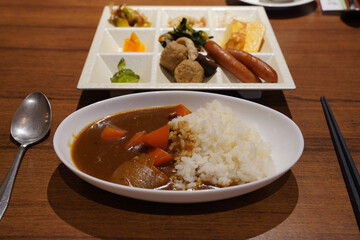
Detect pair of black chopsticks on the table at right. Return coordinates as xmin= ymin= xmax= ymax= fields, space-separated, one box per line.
xmin=320 ymin=97 xmax=360 ymax=229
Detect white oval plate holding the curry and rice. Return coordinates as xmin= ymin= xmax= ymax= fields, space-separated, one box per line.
xmin=54 ymin=91 xmax=304 ymax=203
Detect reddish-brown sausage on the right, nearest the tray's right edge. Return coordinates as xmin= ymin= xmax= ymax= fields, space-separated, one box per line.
xmin=226 ymin=48 xmax=278 ymax=83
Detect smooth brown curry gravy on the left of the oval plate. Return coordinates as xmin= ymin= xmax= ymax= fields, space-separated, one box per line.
xmin=71 ymin=106 xmax=175 ymax=181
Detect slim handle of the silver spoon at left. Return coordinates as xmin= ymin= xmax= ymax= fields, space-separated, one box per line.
xmin=0 ymin=145 xmax=26 ymax=220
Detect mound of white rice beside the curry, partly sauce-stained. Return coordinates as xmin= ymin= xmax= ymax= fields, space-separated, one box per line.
xmin=169 ymin=100 xmax=275 ymax=189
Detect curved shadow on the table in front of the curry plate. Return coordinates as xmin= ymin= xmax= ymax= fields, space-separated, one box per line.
xmin=47 ymin=164 xmax=299 ymax=239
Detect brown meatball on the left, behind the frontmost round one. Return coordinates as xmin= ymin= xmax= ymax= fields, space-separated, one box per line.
xmin=160 ymin=41 xmax=187 ymax=71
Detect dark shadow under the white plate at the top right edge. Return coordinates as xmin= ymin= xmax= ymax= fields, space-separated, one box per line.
xmin=226 ymin=0 xmax=318 ymax=19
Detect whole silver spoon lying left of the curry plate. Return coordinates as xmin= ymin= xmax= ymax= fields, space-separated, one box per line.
xmin=0 ymin=92 xmax=52 ymax=220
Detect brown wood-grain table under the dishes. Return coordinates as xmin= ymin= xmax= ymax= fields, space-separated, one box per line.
xmin=0 ymin=0 xmax=360 ymax=239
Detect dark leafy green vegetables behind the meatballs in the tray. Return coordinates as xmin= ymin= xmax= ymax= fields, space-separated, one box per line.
xmin=158 ymin=18 xmax=213 ymax=49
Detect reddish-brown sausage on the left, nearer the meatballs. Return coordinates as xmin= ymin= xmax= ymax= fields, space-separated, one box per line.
xmin=205 ymin=41 xmax=261 ymax=83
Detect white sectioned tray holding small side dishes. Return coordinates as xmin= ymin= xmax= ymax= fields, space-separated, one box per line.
xmin=77 ymin=6 xmax=296 ymax=98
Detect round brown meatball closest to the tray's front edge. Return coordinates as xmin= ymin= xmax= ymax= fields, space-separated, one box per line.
xmin=174 ymin=59 xmax=204 ymax=83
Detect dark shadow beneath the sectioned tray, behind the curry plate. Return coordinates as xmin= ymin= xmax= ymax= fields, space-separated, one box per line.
xmin=76 ymin=90 xmax=291 ymax=118
